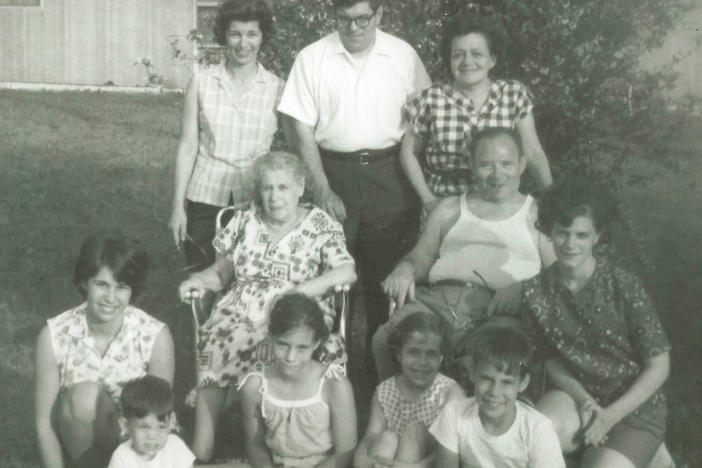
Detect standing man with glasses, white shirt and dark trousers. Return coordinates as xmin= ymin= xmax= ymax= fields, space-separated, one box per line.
xmin=278 ymin=0 xmax=431 ymax=361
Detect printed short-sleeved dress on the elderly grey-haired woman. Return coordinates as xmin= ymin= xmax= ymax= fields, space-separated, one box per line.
xmin=197 ymin=202 xmax=353 ymax=388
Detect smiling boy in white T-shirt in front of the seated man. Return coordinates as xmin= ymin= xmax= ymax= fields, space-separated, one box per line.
xmin=429 ymin=325 xmax=565 ymax=468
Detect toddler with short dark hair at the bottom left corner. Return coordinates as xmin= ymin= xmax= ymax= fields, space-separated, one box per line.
xmin=108 ymin=375 xmax=195 ymax=468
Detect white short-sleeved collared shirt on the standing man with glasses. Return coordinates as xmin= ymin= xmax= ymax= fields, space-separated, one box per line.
xmin=278 ymin=30 xmax=431 ymax=152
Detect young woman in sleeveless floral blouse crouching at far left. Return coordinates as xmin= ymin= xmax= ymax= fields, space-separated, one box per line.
xmin=35 ymin=232 xmax=174 ymax=468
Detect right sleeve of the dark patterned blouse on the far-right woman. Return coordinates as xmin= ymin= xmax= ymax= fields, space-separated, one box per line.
xmin=618 ymin=273 xmax=670 ymax=359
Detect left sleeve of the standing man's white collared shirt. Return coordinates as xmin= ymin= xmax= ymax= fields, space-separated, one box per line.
xmin=278 ymin=49 xmax=319 ymax=126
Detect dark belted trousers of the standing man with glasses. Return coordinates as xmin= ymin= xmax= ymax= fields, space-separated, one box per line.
xmin=320 ymin=147 xmax=419 ymax=353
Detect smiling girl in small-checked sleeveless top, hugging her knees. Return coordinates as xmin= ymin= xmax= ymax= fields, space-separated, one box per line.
xmin=354 ymin=312 xmax=464 ymax=468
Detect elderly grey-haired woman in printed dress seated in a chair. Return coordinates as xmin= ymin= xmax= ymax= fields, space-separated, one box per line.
xmin=180 ymin=152 xmax=356 ymax=460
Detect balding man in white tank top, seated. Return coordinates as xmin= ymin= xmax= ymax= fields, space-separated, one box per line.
xmin=373 ymin=128 xmax=555 ymax=380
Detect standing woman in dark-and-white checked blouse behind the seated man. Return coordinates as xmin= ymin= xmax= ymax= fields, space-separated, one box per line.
xmin=400 ymin=15 xmax=551 ymax=212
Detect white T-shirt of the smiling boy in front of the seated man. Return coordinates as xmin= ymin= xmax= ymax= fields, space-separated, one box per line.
xmin=429 ymin=398 xmax=565 ymax=468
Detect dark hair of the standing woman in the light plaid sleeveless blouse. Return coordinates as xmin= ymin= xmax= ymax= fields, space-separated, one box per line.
xmin=212 ymin=0 xmax=273 ymax=46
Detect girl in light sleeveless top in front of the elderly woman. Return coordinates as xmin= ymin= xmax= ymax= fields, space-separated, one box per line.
xmin=240 ymin=293 xmax=356 ymax=468
